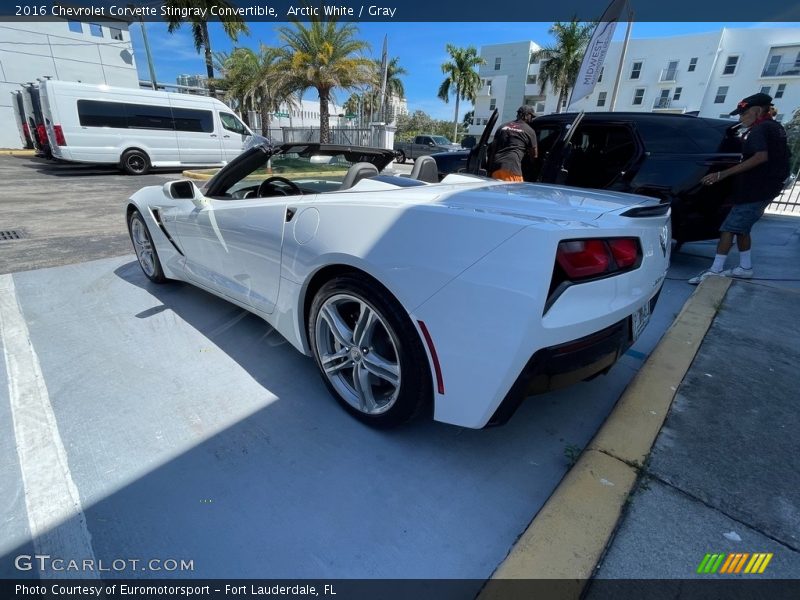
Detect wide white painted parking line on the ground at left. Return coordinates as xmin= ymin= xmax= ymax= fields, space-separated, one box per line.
xmin=0 ymin=274 xmax=97 ymax=579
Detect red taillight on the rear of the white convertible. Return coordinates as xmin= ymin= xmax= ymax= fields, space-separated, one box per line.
xmin=556 ymin=238 xmax=642 ymax=281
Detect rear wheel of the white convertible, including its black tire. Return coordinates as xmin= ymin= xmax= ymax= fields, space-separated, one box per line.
xmin=308 ymin=273 xmax=433 ymax=429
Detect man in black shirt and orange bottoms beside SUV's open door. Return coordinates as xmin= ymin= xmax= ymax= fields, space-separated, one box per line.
xmin=487 ymin=106 xmax=536 ymax=181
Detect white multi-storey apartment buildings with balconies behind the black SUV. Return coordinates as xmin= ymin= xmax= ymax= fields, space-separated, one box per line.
xmin=470 ymin=23 xmax=800 ymax=133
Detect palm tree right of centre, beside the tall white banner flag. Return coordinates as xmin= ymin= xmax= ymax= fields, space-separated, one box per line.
xmin=531 ymin=17 xmax=595 ymax=112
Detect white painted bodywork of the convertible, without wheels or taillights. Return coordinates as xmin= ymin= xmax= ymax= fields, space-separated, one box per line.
xmin=130 ymin=144 xmax=670 ymax=427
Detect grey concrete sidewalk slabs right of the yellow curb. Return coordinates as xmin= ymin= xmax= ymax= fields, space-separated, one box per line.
xmin=587 ymin=281 xmax=800 ymax=598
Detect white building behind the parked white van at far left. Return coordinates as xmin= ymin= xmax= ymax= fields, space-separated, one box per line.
xmin=0 ymin=19 xmax=139 ymax=148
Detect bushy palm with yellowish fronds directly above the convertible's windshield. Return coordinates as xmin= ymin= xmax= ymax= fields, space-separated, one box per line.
xmin=277 ymin=18 xmax=375 ymax=143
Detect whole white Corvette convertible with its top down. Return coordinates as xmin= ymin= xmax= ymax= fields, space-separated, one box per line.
xmin=126 ymin=143 xmax=671 ymax=428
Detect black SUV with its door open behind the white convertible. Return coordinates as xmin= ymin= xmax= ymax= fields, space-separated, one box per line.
xmin=432 ymin=111 xmax=741 ymax=246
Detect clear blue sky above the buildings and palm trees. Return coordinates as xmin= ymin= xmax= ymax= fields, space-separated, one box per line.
xmin=131 ymin=22 xmax=798 ymax=120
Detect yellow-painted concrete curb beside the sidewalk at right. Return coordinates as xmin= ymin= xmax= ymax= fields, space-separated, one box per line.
xmin=479 ymin=277 xmax=731 ymax=600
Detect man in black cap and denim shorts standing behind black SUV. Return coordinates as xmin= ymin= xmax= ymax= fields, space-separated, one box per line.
xmin=689 ymin=94 xmax=789 ymax=285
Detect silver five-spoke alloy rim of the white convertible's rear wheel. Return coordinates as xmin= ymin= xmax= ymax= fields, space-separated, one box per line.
xmin=314 ymin=293 xmax=401 ymax=415
